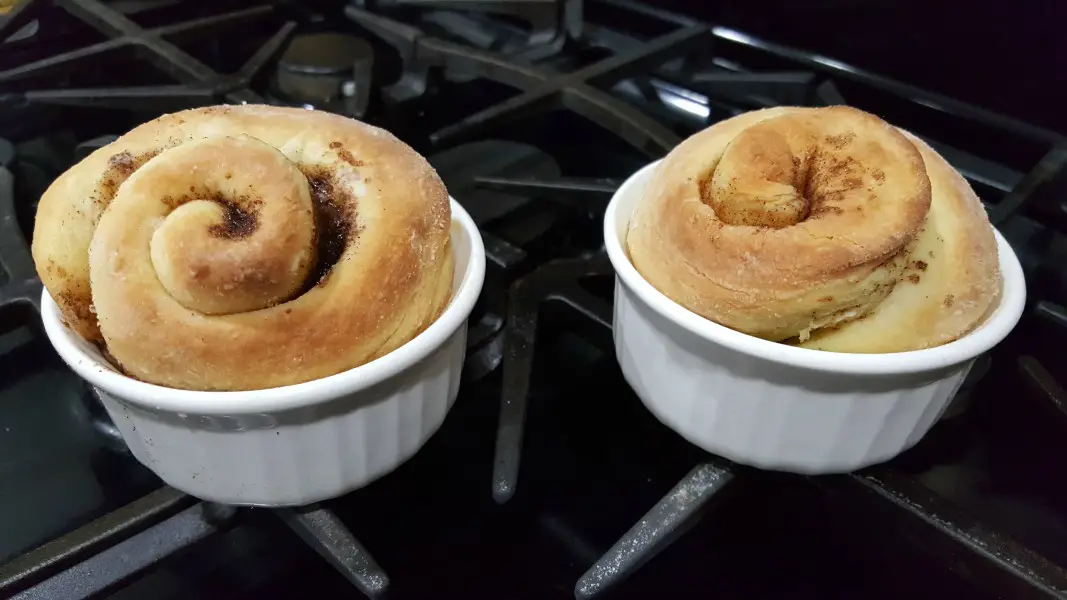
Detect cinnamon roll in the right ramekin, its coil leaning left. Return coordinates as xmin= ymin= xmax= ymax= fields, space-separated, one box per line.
xmin=626 ymin=107 xmax=1000 ymax=352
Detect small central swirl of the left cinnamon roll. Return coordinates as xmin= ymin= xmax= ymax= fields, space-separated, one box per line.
xmin=135 ymin=137 xmax=316 ymax=315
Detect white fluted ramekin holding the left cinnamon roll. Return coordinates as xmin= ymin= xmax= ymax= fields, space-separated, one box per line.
xmin=42 ymin=201 xmax=485 ymax=506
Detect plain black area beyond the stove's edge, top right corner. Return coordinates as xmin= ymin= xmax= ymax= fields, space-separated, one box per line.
xmin=653 ymin=0 xmax=1067 ymax=132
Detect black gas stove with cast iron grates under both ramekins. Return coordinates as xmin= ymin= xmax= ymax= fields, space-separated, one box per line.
xmin=0 ymin=0 xmax=1067 ymax=599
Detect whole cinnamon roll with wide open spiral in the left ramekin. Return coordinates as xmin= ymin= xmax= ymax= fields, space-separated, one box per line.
xmin=33 ymin=106 xmax=453 ymax=390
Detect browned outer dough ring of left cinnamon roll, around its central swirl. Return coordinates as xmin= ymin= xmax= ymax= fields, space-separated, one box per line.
xmin=33 ymin=106 xmax=453 ymax=390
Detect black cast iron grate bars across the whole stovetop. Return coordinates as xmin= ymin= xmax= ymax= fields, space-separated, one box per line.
xmin=0 ymin=0 xmax=1067 ymax=598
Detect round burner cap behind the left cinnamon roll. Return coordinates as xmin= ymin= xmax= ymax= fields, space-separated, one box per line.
xmin=273 ymin=32 xmax=375 ymax=117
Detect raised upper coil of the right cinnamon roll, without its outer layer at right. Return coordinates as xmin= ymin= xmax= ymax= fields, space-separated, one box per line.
xmin=627 ymin=107 xmax=936 ymax=343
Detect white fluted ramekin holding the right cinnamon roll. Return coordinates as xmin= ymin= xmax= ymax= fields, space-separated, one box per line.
xmin=604 ymin=162 xmax=1026 ymax=474
